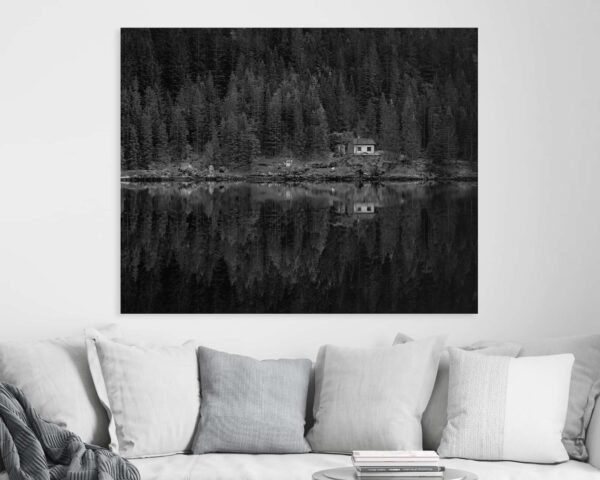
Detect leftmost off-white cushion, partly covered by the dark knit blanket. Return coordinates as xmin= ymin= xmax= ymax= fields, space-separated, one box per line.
xmin=0 ymin=336 xmax=108 ymax=446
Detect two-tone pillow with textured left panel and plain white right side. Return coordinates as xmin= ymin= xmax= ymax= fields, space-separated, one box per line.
xmin=438 ymin=348 xmax=575 ymax=463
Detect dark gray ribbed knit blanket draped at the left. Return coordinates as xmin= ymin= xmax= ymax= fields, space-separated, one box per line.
xmin=0 ymin=383 xmax=140 ymax=480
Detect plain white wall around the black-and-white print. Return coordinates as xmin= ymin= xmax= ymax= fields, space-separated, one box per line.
xmin=0 ymin=0 xmax=600 ymax=357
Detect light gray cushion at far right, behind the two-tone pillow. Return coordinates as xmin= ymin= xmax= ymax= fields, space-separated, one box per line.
xmin=519 ymin=335 xmax=600 ymax=461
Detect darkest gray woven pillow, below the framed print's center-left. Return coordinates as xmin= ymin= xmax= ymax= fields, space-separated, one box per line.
xmin=192 ymin=347 xmax=312 ymax=454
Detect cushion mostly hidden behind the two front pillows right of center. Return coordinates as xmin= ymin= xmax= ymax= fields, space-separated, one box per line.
xmin=394 ymin=333 xmax=521 ymax=450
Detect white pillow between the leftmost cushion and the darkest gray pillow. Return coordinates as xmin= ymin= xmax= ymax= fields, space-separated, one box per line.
xmin=86 ymin=330 xmax=200 ymax=458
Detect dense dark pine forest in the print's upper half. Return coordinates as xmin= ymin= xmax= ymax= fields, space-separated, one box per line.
xmin=121 ymin=29 xmax=477 ymax=170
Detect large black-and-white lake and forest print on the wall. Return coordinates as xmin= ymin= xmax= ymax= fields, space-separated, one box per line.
xmin=120 ymin=28 xmax=478 ymax=313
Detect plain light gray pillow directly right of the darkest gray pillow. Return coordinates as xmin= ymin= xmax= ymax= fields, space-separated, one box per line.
xmin=307 ymin=337 xmax=444 ymax=453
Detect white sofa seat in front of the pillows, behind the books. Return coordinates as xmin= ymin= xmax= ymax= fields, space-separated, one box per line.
xmin=126 ymin=453 xmax=600 ymax=480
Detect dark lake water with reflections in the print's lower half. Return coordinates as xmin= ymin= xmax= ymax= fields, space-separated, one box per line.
xmin=121 ymin=183 xmax=477 ymax=313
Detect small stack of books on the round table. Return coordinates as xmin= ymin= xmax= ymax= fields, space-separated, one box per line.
xmin=352 ymin=450 xmax=444 ymax=480
